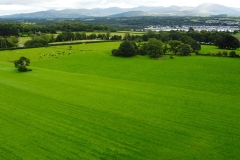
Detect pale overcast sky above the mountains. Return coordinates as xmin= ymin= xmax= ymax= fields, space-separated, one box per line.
xmin=0 ymin=0 xmax=240 ymax=15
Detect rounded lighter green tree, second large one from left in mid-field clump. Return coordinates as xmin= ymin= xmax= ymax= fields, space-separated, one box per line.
xmin=144 ymin=38 xmax=164 ymax=58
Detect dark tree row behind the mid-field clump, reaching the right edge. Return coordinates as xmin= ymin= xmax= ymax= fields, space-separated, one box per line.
xmin=124 ymin=28 xmax=240 ymax=51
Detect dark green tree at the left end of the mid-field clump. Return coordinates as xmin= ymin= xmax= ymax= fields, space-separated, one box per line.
xmin=112 ymin=41 xmax=137 ymax=57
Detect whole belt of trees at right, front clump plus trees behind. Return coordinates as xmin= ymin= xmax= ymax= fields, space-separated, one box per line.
xmin=112 ymin=28 xmax=240 ymax=58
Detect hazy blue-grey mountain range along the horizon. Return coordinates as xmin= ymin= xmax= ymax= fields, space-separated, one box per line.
xmin=0 ymin=3 xmax=240 ymax=19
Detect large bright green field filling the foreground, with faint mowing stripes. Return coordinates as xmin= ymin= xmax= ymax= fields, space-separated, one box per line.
xmin=0 ymin=42 xmax=240 ymax=160
